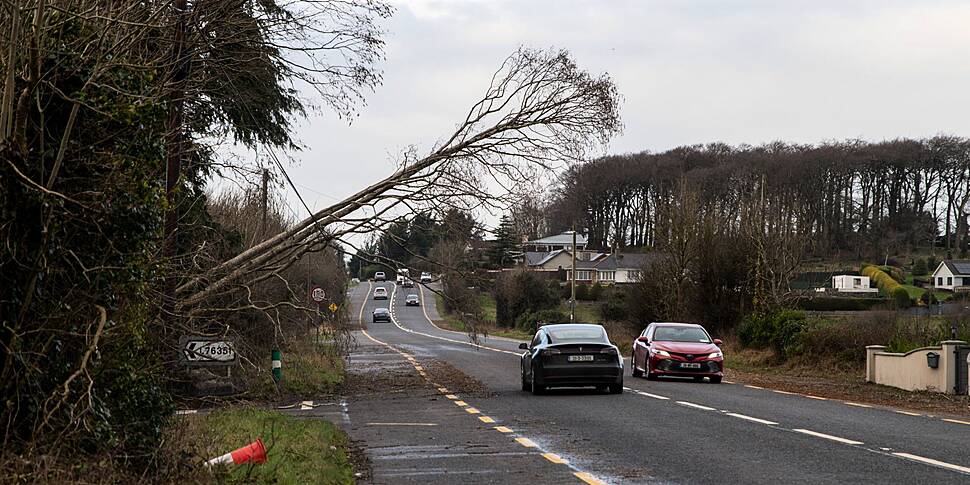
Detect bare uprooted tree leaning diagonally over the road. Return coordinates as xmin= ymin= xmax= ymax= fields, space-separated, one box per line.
xmin=177 ymin=48 xmax=622 ymax=311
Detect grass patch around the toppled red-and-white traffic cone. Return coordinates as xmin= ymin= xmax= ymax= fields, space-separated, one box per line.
xmin=170 ymin=408 xmax=354 ymax=484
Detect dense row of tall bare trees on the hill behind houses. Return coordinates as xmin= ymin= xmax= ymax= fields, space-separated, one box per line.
xmin=548 ymin=136 xmax=970 ymax=259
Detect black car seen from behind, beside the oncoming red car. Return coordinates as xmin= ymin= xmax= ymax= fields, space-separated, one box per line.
xmin=519 ymin=323 xmax=623 ymax=394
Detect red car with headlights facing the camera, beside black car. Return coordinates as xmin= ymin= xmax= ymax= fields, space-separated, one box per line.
xmin=630 ymin=323 xmax=724 ymax=384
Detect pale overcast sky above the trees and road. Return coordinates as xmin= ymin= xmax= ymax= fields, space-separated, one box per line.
xmin=270 ymin=0 xmax=970 ymax=233
